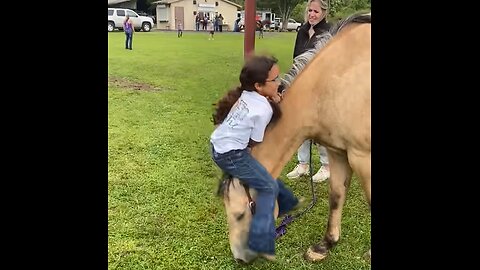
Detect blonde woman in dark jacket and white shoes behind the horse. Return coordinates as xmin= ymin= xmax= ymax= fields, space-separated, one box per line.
xmin=287 ymin=0 xmax=330 ymax=183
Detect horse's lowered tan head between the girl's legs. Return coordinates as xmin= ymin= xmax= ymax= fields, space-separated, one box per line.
xmin=218 ymin=178 xmax=278 ymax=263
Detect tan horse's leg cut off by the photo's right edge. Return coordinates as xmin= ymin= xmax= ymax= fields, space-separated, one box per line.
xmin=348 ymin=152 xmax=372 ymax=261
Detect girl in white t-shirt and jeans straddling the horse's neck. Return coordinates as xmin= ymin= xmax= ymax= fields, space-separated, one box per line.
xmin=210 ymin=56 xmax=298 ymax=260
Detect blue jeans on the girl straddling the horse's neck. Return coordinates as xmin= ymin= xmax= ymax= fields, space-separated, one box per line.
xmin=212 ymin=146 xmax=298 ymax=255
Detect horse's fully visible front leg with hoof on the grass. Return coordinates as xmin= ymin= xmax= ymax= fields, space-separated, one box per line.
xmin=305 ymin=151 xmax=352 ymax=261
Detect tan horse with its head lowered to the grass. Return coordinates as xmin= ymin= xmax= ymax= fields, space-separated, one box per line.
xmin=219 ymin=13 xmax=371 ymax=262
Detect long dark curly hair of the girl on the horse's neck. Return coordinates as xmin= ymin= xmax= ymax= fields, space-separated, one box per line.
xmin=212 ymin=56 xmax=280 ymax=125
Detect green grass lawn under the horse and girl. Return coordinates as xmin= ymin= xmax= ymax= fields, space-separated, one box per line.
xmin=108 ymin=32 xmax=371 ymax=270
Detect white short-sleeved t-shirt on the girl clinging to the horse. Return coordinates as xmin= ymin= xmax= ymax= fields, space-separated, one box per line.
xmin=210 ymin=91 xmax=273 ymax=154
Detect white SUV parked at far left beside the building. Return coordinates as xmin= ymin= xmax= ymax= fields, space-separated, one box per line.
xmin=108 ymin=8 xmax=153 ymax=32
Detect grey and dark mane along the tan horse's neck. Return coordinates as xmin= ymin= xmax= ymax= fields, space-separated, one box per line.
xmin=281 ymin=13 xmax=371 ymax=91
